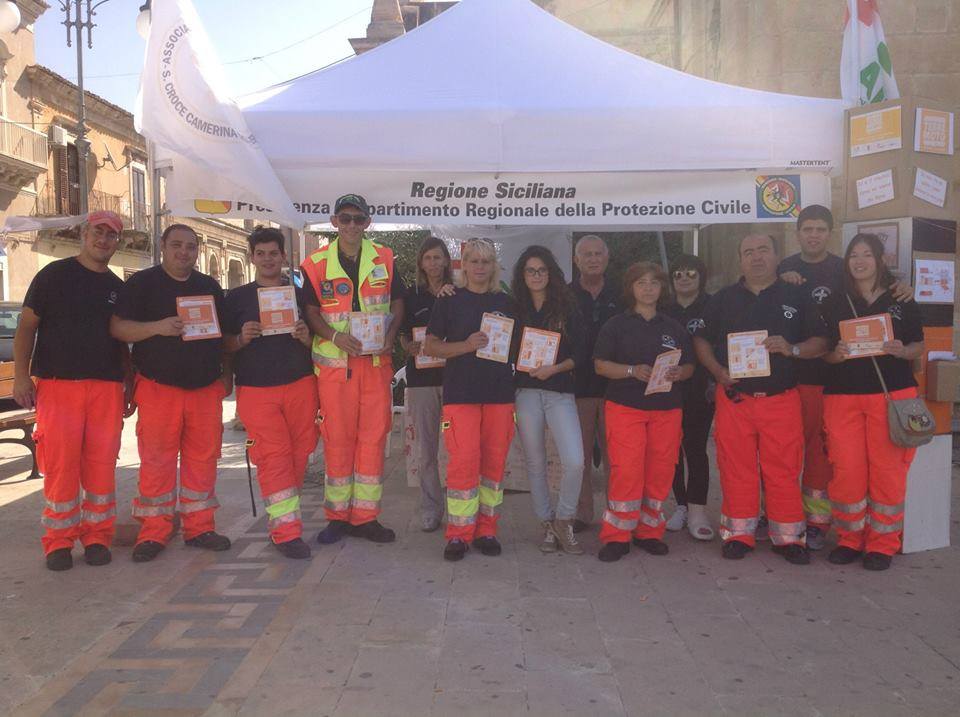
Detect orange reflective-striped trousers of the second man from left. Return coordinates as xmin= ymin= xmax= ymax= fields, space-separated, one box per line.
xmin=133 ymin=375 xmax=224 ymax=545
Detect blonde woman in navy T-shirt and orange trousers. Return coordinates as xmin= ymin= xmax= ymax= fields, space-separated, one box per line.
xmin=423 ymin=239 xmax=517 ymax=560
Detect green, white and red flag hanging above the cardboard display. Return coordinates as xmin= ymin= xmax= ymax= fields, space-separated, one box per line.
xmin=840 ymin=0 xmax=900 ymax=107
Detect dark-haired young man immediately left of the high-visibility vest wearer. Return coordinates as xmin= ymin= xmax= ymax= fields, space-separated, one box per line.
xmin=224 ymin=227 xmax=318 ymax=558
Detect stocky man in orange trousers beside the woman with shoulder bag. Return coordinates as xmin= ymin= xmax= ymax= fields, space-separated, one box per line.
xmin=694 ymin=234 xmax=826 ymax=565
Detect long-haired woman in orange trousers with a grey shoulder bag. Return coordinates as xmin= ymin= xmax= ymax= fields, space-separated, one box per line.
xmin=823 ymin=234 xmax=923 ymax=570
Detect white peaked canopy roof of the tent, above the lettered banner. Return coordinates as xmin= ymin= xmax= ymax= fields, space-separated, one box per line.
xmin=241 ymin=0 xmax=843 ymax=176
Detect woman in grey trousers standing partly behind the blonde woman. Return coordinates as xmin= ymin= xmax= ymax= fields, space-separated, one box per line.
xmin=400 ymin=237 xmax=453 ymax=533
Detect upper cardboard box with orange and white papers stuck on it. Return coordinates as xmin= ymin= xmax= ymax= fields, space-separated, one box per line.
xmin=843 ymin=97 xmax=960 ymax=222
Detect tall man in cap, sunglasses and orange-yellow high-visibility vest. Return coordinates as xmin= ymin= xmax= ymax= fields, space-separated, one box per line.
xmin=301 ymin=194 xmax=404 ymax=544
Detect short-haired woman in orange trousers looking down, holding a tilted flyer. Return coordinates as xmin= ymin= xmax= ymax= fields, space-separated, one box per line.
xmin=593 ymin=262 xmax=693 ymax=562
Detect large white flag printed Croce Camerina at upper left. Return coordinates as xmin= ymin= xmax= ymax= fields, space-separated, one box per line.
xmin=135 ymin=0 xmax=302 ymax=226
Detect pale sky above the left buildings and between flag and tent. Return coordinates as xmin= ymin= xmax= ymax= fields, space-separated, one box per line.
xmin=35 ymin=0 xmax=373 ymax=112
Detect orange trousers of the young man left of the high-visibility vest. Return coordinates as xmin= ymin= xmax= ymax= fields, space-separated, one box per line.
xmin=237 ymin=376 xmax=318 ymax=543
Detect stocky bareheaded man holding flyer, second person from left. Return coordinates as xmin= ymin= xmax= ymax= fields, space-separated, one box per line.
xmin=110 ymin=224 xmax=232 ymax=562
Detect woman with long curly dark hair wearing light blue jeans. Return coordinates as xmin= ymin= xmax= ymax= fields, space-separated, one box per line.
xmin=511 ymin=246 xmax=583 ymax=555
